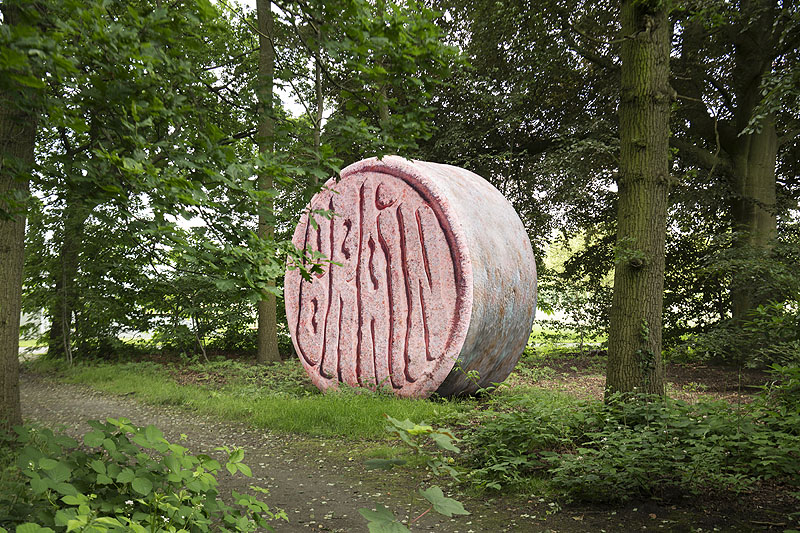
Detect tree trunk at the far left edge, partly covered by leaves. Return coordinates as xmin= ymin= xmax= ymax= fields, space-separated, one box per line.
xmin=0 ymin=7 xmax=37 ymax=429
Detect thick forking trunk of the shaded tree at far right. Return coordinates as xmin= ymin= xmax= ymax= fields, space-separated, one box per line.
xmin=674 ymin=0 xmax=786 ymax=321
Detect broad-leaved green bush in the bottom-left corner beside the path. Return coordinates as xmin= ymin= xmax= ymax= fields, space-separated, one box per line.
xmin=0 ymin=418 xmax=286 ymax=533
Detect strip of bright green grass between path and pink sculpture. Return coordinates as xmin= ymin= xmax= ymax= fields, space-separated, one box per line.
xmin=35 ymin=362 xmax=471 ymax=439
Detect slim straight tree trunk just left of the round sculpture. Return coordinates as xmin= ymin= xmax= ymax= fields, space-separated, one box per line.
xmin=256 ymin=0 xmax=281 ymax=363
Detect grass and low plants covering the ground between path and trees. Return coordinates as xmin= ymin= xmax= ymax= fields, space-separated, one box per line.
xmin=18 ymin=348 xmax=800 ymax=527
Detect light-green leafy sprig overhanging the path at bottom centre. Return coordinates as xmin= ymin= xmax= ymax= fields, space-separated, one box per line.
xmin=358 ymin=415 xmax=469 ymax=533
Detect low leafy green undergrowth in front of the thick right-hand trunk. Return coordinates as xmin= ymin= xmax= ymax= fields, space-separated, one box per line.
xmin=468 ymin=388 xmax=800 ymax=501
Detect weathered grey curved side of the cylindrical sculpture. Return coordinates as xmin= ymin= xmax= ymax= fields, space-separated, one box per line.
xmin=406 ymin=161 xmax=536 ymax=396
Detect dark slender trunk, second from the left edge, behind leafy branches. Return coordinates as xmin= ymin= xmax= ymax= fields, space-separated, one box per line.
xmin=47 ymin=191 xmax=89 ymax=364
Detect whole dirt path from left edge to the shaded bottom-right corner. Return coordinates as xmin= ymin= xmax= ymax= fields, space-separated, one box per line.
xmin=20 ymin=373 xmax=785 ymax=533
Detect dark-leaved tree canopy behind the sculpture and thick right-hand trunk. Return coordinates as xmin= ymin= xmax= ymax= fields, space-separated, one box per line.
xmin=425 ymin=0 xmax=800 ymax=366
